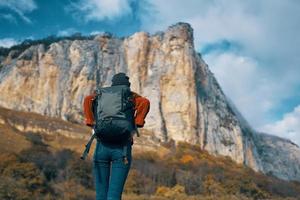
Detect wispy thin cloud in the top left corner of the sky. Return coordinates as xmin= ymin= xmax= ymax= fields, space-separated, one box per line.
xmin=0 ymin=0 xmax=37 ymax=23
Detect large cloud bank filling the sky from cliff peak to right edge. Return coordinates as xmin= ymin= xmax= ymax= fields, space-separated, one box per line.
xmin=142 ymin=0 xmax=300 ymax=134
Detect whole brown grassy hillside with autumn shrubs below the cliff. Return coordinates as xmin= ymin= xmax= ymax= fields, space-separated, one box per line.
xmin=0 ymin=105 xmax=300 ymax=200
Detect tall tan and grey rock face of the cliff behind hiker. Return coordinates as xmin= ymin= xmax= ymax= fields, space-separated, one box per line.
xmin=0 ymin=23 xmax=300 ymax=180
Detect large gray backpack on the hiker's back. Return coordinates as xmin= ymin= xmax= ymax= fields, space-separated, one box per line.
xmin=93 ymin=85 xmax=135 ymax=144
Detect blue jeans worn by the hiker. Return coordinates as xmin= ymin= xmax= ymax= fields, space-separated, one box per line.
xmin=93 ymin=141 xmax=131 ymax=200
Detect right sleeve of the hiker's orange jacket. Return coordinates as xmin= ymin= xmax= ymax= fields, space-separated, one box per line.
xmin=133 ymin=92 xmax=150 ymax=127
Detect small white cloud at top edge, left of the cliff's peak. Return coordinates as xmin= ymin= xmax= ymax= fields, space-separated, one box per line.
xmin=71 ymin=0 xmax=132 ymax=21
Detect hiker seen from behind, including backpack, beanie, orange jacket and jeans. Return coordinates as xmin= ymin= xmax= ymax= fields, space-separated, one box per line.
xmin=83 ymin=73 xmax=150 ymax=200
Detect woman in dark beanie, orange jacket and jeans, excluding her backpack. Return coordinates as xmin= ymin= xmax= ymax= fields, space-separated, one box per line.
xmin=84 ymin=73 xmax=150 ymax=200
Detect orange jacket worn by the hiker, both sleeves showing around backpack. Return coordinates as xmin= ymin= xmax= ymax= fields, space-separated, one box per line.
xmin=83 ymin=92 xmax=150 ymax=127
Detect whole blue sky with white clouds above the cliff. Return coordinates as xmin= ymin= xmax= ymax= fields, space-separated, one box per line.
xmin=0 ymin=0 xmax=300 ymax=145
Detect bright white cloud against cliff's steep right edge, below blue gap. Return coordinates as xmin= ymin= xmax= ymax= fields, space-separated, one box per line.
xmin=204 ymin=52 xmax=283 ymax=126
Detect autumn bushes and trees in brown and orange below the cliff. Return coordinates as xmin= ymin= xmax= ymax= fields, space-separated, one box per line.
xmin=0 ymin=134 xmax=300 ymax=200
